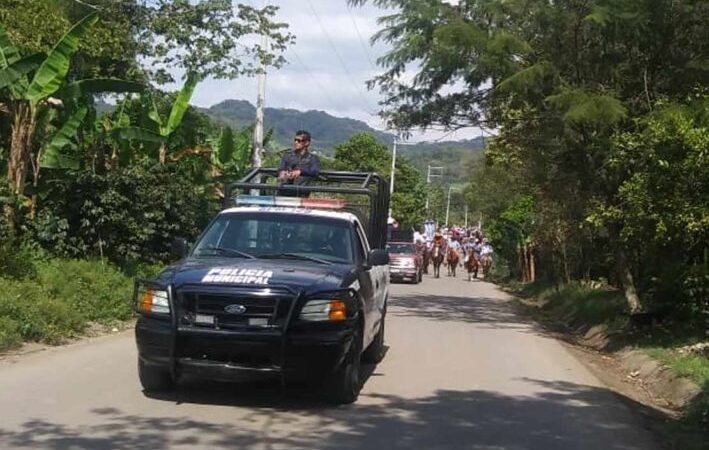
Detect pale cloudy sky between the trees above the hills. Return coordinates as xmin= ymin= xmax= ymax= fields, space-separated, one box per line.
xmin=193 ymin=0 xmax=480 ymax=141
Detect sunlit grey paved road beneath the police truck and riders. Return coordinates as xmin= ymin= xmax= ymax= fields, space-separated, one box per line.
xmin=0 ymin=277 xmax=654 ymax=450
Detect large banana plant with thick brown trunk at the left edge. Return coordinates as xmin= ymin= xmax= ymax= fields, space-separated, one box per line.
xmin=0 ymin=13 xmax=142 ymax=218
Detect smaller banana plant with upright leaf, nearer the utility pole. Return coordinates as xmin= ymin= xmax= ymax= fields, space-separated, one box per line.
xmin=115 ymin=75 xmax=199 ymax=164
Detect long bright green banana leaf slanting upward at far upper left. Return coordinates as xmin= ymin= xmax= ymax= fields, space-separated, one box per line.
xmin=26 ymin=13 xmax=98 ymax=106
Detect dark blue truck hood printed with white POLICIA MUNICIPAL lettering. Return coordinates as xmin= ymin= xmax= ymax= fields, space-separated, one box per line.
xmin=157 ymin=258 xmax=356 ymax=293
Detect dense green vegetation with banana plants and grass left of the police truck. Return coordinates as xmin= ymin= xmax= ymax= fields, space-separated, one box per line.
xmin=0 ymin=0 xmax=290 ymax=349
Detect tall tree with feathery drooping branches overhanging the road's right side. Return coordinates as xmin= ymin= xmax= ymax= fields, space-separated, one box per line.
xmin=350 ymin=0 xmax=709 ymax=312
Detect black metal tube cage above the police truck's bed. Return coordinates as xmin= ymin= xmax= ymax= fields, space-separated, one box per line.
xmin=222 ymin=168 xmax=390 ymax=249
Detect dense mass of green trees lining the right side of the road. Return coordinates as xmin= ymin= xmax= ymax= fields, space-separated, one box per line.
xmin=352 ymin=0 xmax=709 ymax=328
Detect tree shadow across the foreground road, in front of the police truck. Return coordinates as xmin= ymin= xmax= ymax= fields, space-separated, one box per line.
xmin=0 ymin=379 xmax=660 ymax=450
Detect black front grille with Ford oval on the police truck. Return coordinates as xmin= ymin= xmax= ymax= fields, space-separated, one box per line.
xmin=177 ymin=292 xmax=292 ymax=330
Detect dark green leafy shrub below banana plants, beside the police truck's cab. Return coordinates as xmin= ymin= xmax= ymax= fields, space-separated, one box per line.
xmin=27 ymin=162 xmax=216 ymax=266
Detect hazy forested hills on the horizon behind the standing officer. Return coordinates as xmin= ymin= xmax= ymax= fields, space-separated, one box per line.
xmin=204 ymin=100 xmax=483 ymax=163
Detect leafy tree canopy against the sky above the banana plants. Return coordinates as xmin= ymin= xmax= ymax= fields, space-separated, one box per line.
xmin=0 ymin=0 xmax=292 ymax=84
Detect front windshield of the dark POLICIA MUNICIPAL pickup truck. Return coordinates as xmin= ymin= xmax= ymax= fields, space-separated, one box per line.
xmin=193 ymin=212 xmax=355 ymax=264
